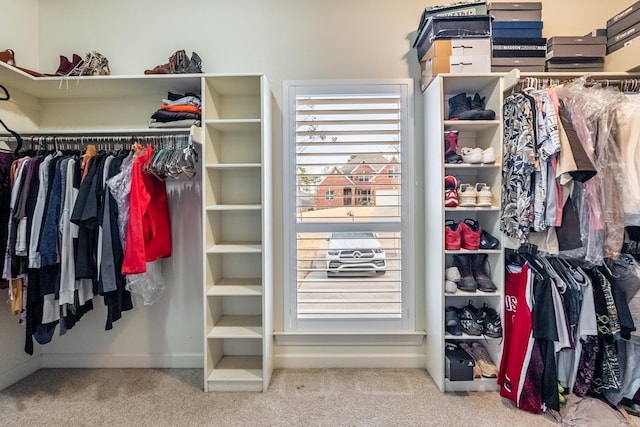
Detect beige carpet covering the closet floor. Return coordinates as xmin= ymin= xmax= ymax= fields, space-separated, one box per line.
xmin=0 ymin=369 xmax=557 ymax=427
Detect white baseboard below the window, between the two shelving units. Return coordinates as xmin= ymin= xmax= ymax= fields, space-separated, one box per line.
xmin=274 ymin=353 xmax=425 ymax=369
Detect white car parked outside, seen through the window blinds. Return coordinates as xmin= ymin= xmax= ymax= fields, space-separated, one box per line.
xmin=326 ymin=231 xmax=387 ymax=277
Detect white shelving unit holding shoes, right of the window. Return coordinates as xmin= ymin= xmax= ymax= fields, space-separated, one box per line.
xmin=423 ymin=74 xmax=504 ymax=391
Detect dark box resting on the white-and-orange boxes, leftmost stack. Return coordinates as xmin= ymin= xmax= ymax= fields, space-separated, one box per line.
xmin=413 ymin=15 xmax=491 ymax=61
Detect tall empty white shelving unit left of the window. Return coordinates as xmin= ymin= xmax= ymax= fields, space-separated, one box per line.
xmin=202 ymin=75 xmax=273 ymax=391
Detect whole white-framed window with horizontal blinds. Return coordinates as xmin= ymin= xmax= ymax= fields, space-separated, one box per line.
xmin=283 ymin=80 xmax=414 ymax=331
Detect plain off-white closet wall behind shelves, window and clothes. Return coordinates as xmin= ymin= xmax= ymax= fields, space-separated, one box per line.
xmin=0 ymin=0 xmax=633 ymax=388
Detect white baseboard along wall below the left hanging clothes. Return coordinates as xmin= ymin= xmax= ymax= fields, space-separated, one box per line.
xmin=42 ymin=353 xmax=204 ymax=369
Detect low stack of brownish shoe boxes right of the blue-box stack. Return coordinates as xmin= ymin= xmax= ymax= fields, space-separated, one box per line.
xmin=547 ymin=30 xmax=607 ymax=73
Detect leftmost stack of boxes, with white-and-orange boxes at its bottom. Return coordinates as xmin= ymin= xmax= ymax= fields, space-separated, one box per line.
xmin=413 ymin=1 xmax=491 ymax=90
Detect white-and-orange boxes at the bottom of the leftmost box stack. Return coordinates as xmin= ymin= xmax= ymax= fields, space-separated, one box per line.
xmin=420 ymin=37 xmax=491 ymax=87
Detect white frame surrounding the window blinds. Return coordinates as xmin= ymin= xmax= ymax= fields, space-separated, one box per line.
xmin=282 ymin=79 xmax=416 ymax=333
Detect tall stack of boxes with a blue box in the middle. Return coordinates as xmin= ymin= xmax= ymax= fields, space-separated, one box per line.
xmin=488 ymin=2 xmax=547 ymax=72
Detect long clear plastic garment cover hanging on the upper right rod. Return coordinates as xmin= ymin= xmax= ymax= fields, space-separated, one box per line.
xmin=558 ymin=79 xmax=625 ymax=265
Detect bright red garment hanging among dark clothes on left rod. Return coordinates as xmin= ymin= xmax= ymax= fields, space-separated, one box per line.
xmin=122 ymin=146 xmax=171 ymax=275
